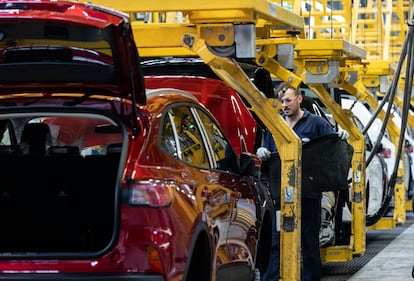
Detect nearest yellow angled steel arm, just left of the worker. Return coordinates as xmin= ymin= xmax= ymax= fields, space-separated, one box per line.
xmin=185 ymin=33 xmax=302 ymax=280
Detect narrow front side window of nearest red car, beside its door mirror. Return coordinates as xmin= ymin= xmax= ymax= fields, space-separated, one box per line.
xmin=198 ymin=110 xmax=237 ymax=172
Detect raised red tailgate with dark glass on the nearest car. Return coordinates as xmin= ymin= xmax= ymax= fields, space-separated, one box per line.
xmin=0 ymin=0 xmax=146 ymax=104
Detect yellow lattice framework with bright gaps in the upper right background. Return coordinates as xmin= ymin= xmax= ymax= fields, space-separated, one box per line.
xmin=288 ymin=0 xmax=412 ymax=70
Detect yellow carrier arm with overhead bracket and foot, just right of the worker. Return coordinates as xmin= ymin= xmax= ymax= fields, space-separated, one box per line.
xmin=295 ymin=39 xmax=366 ymax=262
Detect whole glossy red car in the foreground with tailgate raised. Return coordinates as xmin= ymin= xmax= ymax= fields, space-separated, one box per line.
xmin=0 ymin=1 xmax=272 ymax=281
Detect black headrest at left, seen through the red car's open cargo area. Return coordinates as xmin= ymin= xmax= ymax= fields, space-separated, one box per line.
xmin=20 ymin=123 xmax=52 ymax=155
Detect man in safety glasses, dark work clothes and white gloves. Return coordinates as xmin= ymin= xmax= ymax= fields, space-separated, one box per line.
xmin=257 ymin=83 xmax=349 ymax=281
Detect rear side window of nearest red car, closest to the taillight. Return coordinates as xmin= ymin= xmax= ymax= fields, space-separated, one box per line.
xmin=162 ymin=106 xmax=210 ymax=169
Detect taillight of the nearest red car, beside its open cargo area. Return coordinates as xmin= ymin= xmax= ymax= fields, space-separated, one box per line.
xmin=129 ymin=180 xmax=176 ymax=207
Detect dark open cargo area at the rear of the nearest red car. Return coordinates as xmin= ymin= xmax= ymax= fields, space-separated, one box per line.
xmin=0 ymin=112 xmax=122 ymax=255
